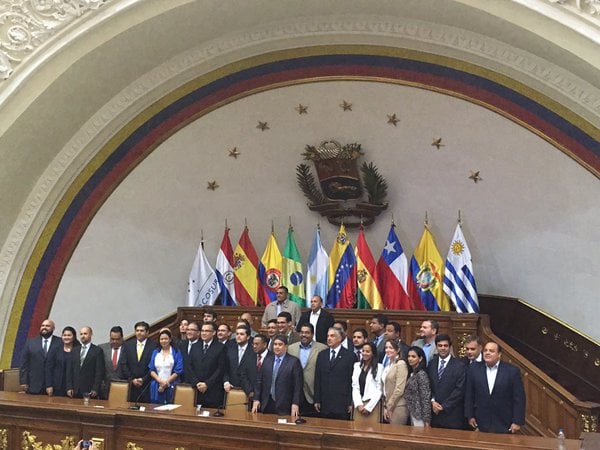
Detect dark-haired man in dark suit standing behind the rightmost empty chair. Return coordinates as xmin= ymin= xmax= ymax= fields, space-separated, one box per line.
xmin=223 ymin=325 xmax=256 ymax=395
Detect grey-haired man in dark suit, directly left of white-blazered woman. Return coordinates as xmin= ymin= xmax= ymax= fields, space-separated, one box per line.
xmin=314 ymin=327 xmax=356 ymax=420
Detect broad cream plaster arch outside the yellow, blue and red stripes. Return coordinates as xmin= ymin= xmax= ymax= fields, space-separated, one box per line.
xmin=0 ymin=0 xmax=600 ymax=364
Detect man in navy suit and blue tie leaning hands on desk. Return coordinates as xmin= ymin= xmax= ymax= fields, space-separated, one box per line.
xmin=252 ymin=334 xmax=302 ymax=417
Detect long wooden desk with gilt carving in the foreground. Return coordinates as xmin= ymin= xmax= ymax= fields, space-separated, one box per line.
xmin=0 ymin=392 xmax=580 ymax=450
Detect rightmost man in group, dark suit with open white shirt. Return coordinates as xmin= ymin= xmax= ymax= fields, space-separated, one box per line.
xmin=465 ymin=342 xmax=525 ymax=433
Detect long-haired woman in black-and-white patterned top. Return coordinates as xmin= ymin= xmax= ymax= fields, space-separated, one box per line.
xmin=404 ymin=346 xmax=431 ymax=427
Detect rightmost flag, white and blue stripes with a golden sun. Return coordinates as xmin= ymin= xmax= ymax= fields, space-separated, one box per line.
xmin=444 ymin=224 xmax=479 ymax=313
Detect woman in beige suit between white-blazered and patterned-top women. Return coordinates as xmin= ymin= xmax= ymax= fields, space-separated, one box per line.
xmin=382 ymin=339 xmax=408 ymax=425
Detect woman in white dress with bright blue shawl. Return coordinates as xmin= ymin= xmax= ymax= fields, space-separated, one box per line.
xmin=148 ymin=329 xmax=183 ymax=404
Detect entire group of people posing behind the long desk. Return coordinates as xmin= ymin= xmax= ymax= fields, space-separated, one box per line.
xmin=20 ymin=287 xmax=525 ymax=433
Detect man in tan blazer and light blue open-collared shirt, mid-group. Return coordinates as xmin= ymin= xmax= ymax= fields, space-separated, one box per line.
xmin=288 ymin=322 xmax=327 ymax=416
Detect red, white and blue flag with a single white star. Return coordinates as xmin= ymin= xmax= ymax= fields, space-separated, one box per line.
xmin=377 ymin=224 xmax=414 ymax=309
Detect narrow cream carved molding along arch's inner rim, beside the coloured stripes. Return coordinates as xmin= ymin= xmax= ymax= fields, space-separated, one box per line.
xmin=0 ymin=11 xmax=600 ymax=348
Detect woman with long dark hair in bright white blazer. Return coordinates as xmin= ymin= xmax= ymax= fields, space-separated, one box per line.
xmin=352 ymin=342 xmax=383 ymax=416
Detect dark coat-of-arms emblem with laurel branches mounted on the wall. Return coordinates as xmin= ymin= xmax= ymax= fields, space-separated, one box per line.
xmin=296 ymin=140 xmax=388 ymax=226
